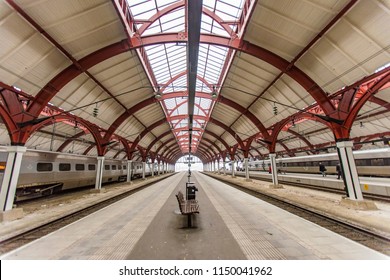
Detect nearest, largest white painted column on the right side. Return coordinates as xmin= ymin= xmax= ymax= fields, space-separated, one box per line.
xmin=336 ymin=141 xmax=363 ymax=200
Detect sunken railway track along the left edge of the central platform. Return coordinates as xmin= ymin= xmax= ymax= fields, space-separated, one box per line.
xmin=0 ymin=177 xmax=171 ymax=255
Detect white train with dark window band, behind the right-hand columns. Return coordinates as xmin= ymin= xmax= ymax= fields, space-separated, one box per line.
xmin=248 ymin=148 xmax=390 ymax=177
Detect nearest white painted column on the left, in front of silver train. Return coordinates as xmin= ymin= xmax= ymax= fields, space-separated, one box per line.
xmin=0 ymin=146 xmax=27 ymax=211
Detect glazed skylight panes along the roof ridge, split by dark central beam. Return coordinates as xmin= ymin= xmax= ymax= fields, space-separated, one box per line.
xmin=127 ymin=0 xmax=244 ymax=152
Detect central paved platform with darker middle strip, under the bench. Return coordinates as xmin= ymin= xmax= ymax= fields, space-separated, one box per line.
xmin=0 ymin=172 xmax=390 ymax=260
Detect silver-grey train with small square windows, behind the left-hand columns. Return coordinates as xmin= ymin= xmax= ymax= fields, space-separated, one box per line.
xmin=0 ymin=147 xmax=171 ymax=201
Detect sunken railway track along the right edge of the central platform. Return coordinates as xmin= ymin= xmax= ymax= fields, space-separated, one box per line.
xmin=205 ymin=173 xmax=390 ymax=256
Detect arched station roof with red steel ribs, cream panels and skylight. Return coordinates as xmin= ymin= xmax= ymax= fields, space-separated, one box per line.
xmin=0 ymin=0 xmax=390 ymax=162
